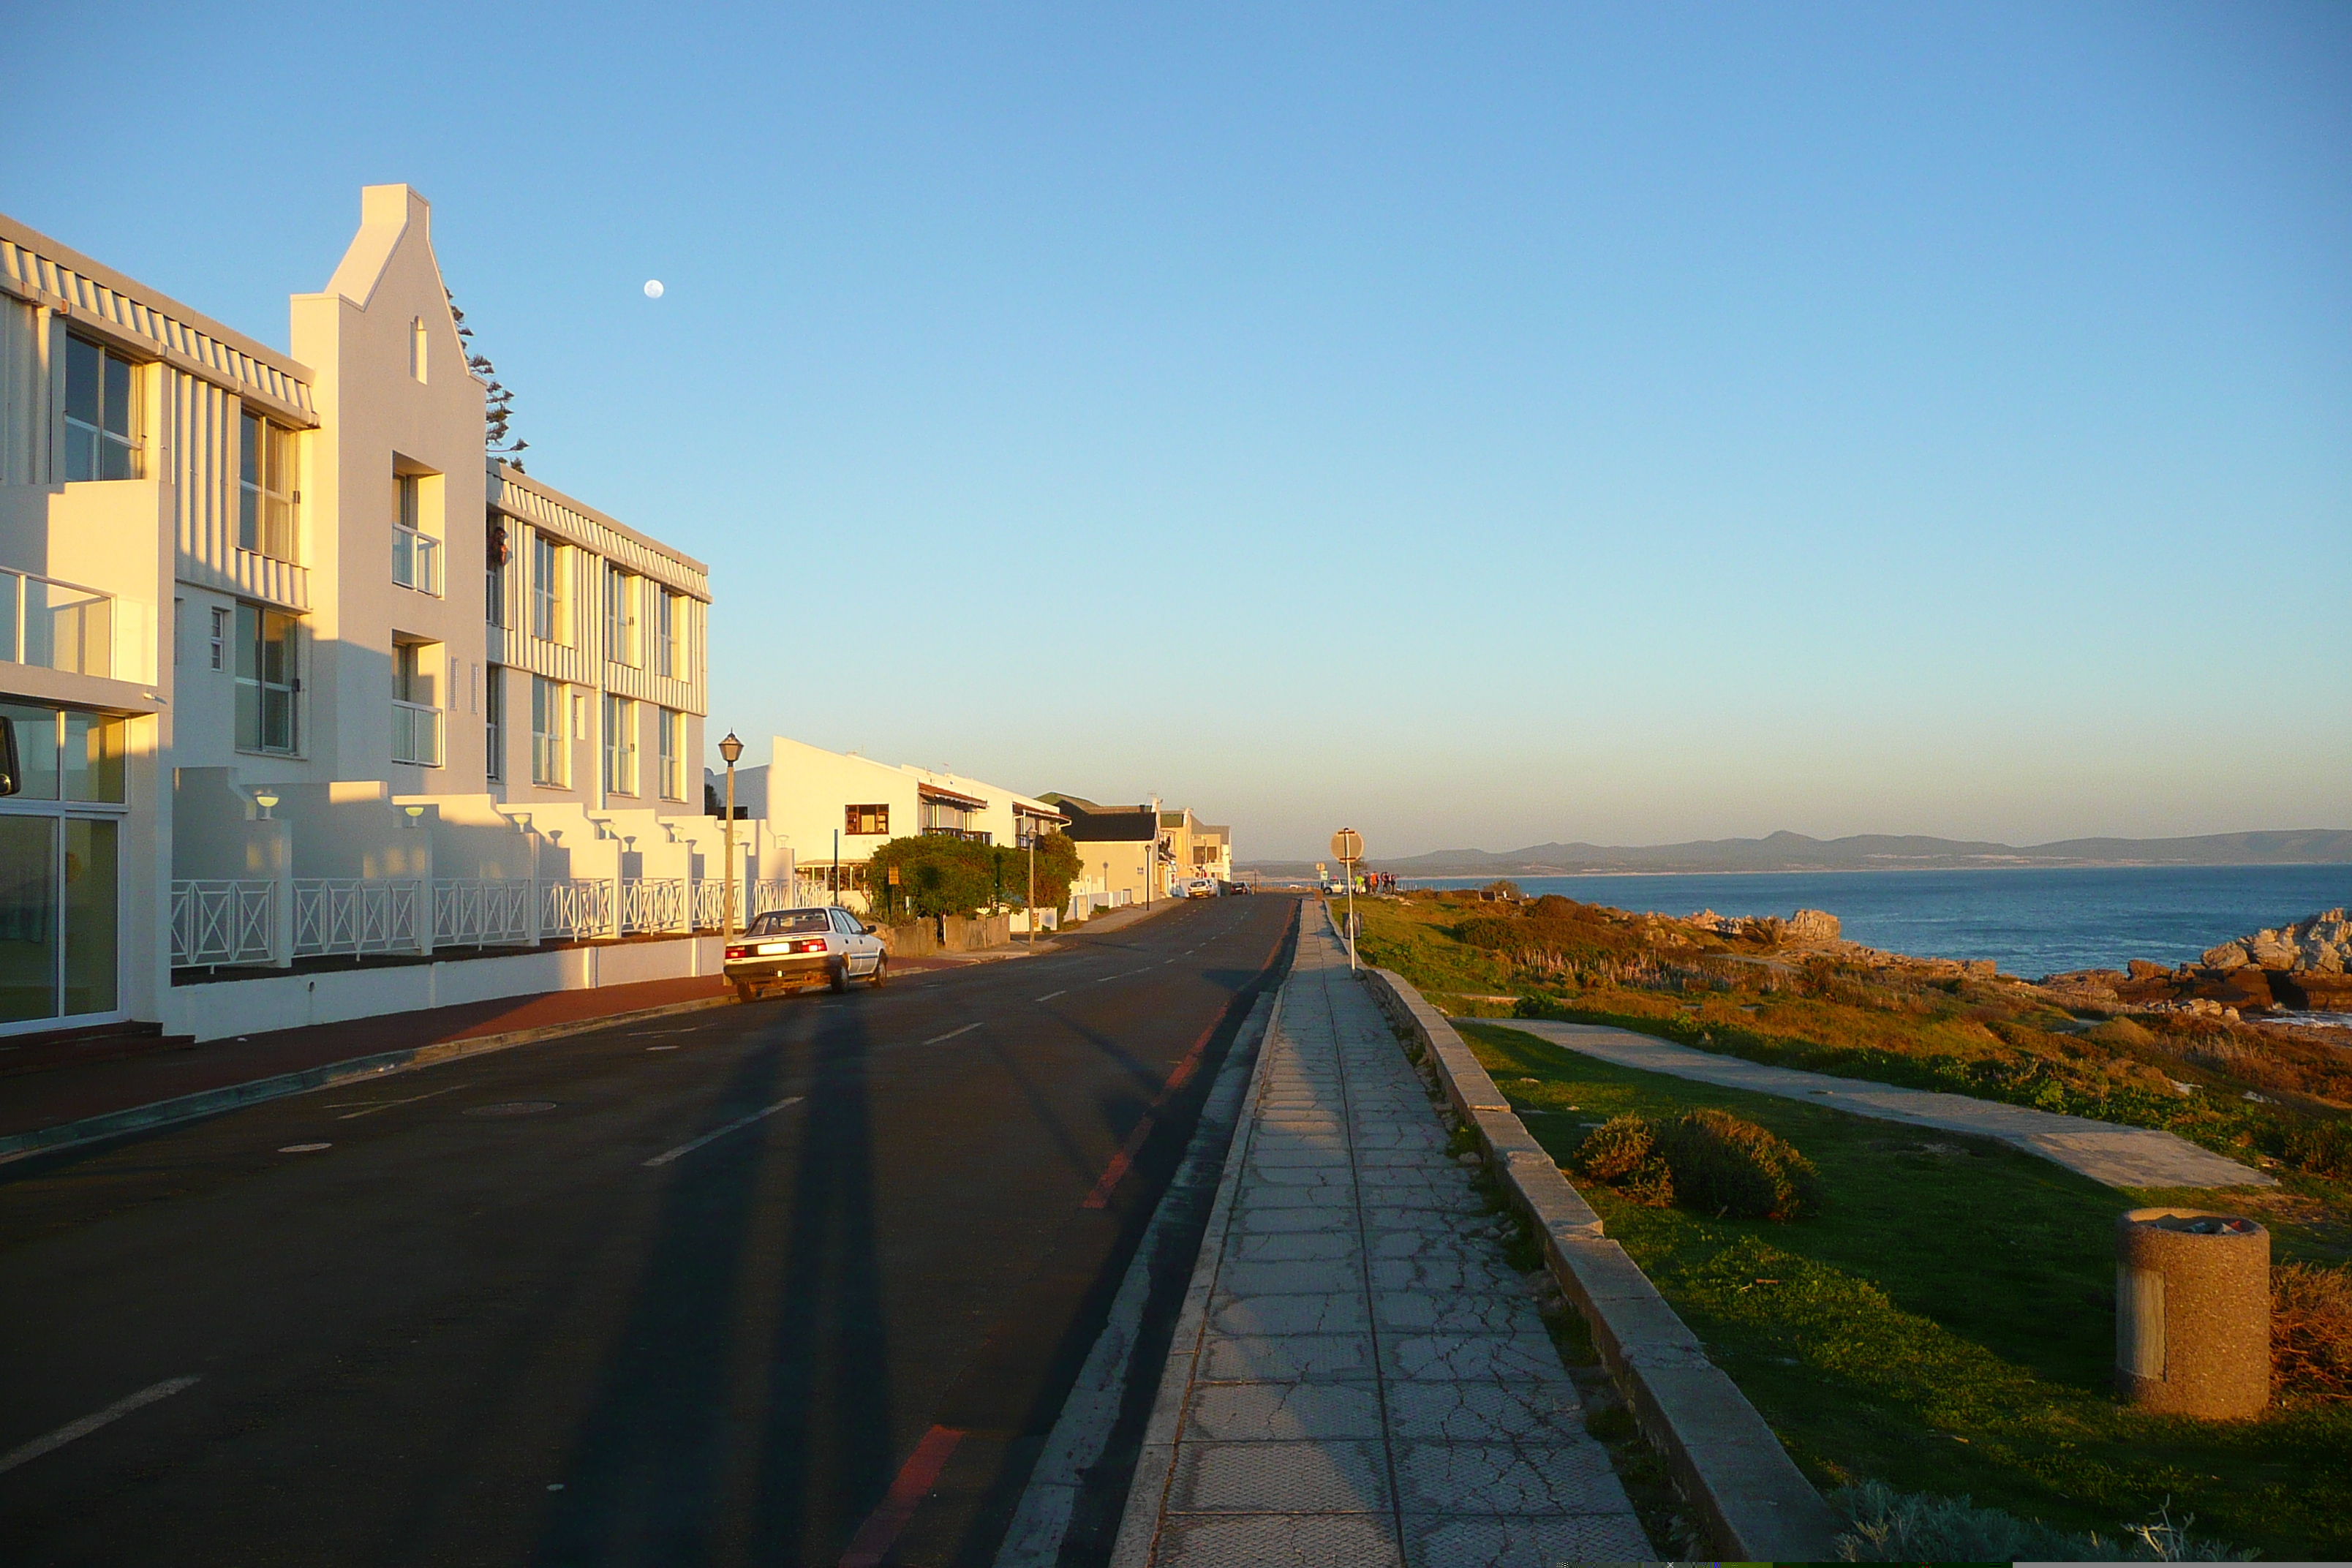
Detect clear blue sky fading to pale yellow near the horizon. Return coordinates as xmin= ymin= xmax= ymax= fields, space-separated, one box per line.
xmin=0 ymin=2 xmax=2352 ymax=858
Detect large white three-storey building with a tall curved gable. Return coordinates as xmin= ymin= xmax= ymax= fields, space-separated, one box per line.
xmin=0 ymin=186 xmax=758 ymax=1037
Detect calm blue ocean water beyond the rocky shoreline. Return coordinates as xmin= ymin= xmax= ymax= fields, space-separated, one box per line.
xmin=1409 ymin=865 xmax=2352 ymax=980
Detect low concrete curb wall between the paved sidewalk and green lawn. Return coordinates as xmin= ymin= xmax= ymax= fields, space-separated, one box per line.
xmin=1362 ymin=968 xmax=1839 ymax=1564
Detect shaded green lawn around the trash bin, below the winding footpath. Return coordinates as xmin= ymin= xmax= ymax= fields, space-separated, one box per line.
xmin=1463 ymin=1025 xmax=2352 ymax=1558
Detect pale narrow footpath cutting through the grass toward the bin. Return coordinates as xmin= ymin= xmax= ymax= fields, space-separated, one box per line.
xmin=1496 ymin=1018 xmax=2277 ymax=1187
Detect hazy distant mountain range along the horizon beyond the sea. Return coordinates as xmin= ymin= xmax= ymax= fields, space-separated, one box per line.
xmin=1244 ymin=827 xmax=2352 ymax=877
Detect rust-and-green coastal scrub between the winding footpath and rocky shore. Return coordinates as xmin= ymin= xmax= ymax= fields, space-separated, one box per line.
xmin=1357 ymin=891 xmax=2352 ymax=1225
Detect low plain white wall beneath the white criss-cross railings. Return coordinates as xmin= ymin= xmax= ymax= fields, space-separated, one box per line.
xmin=162 ymin=935 xmax=720 ymax=1039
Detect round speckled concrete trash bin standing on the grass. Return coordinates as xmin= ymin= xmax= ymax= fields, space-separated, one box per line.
xmin=2114 ymin=1208 xmax=2269 ymax=1420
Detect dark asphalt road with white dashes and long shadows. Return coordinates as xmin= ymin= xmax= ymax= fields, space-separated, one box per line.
xmin=0 ymin=896 xmax=1298 ymax=1566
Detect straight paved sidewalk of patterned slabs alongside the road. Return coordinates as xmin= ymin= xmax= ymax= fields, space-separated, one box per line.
xmin=1112 ymin=910 xmax=1656 ymax=1568
